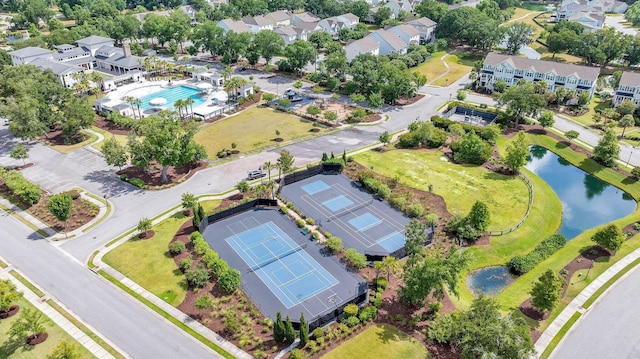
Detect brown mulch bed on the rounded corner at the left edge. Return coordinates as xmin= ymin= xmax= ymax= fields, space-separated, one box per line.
xmin=0 ymin=184 xmax=100 ymax=233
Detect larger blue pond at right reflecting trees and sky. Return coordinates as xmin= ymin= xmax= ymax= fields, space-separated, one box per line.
xmin=525 ymin=146 xmax=636 ymax=240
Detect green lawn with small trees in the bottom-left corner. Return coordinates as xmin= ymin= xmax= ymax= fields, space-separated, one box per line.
xmin=0 ymin=298 xmax=95 ymax=359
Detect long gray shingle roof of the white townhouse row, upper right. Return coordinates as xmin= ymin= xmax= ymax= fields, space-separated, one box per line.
xmin=484 ymin=52 xmax=600 ymax=81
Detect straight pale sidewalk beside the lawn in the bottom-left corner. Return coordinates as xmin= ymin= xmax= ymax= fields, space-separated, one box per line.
xmin=0 ymin=263 xmax=124 ymax=359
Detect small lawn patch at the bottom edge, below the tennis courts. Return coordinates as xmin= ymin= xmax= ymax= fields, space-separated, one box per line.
xmin=322 ymin=324 xmax=431 ymax=359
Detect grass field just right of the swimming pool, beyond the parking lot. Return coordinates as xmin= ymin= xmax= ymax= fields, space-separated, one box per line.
xmin=195 ymin=107 xmax=318 ymax=159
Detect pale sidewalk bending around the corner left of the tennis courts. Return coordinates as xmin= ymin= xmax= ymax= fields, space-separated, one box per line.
xmin=91 ymin=195 xmax=252 ymax=359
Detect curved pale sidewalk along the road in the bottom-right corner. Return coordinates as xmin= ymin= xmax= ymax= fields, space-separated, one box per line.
xmin=535 ymin=248 xmax=640 ymax=357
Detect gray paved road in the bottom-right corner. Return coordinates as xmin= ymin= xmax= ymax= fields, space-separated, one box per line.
xmin=552 ymin=267 xmax=640 ymax=359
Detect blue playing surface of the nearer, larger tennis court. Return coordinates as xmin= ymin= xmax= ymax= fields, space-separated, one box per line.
xmin=225 ymin=222 xmax=338 ymax=308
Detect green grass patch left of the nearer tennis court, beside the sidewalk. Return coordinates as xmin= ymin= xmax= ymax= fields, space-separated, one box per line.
xmin=103 ymin=212 xmax=222 ymax=306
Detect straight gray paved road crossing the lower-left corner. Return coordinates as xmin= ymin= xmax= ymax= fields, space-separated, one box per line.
xmin=0 ymin=211 xmax=217 ymax=359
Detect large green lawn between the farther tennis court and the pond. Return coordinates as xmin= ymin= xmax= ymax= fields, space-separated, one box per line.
xmin=354 ymin=150 xmax=529 ymax=230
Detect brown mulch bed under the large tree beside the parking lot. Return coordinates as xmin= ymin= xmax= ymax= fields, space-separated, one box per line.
xmin=116 ymin=161 xmax=207 ymax=187
